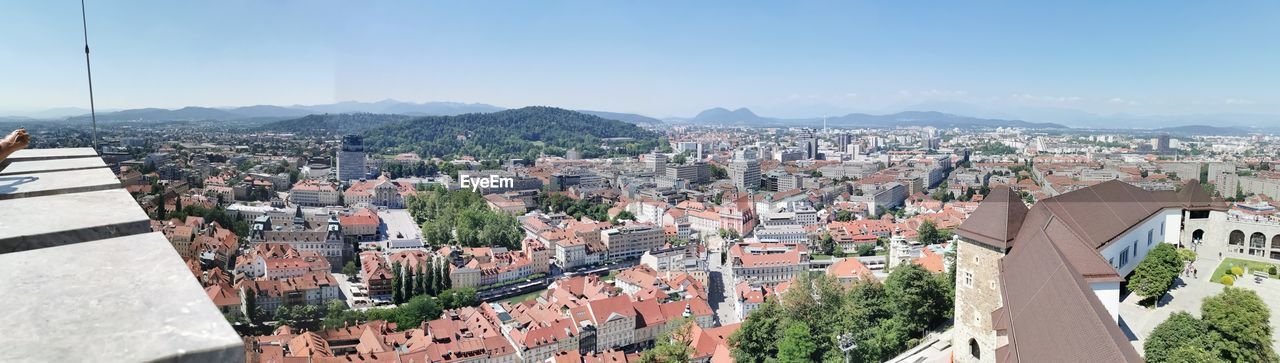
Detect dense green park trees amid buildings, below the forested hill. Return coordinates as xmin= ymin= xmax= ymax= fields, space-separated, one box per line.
xmin=404 ymin=185 xmax=524 ymax=249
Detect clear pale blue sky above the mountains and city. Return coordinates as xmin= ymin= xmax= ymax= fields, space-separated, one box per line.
xmin=0 ymin=0 xmax=1280 ymax=116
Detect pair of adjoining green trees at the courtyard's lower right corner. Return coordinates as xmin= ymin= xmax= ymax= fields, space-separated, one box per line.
xmin=1143 ymin=288 xmax=1280 ymax=363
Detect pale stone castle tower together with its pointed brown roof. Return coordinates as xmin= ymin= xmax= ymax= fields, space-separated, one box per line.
xmin=951 ymin=187 xmax=1027 ymax=362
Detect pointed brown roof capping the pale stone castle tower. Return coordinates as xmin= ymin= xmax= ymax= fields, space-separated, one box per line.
xmin=956 ymin=187 xmax=1027 ymax=251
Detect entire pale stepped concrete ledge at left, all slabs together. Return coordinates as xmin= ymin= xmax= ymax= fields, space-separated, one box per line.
xmin=0 ymin=148 xmax=244 ymax=362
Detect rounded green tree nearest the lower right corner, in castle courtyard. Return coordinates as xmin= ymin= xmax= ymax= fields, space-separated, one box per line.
xmin=1201 ymin=286 xmax=1277 ymax=362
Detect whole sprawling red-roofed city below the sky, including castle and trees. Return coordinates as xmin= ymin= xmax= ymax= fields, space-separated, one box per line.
xmin=7 ymin=107 xmax=1280 ymax=362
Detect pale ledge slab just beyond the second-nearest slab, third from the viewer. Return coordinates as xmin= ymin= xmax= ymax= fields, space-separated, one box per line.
xmin=0 ymin=167 xmax=120 ymax=201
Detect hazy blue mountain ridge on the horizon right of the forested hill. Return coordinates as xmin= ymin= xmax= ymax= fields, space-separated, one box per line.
xmin=667 ymin=107 xmax=1068 ymax=129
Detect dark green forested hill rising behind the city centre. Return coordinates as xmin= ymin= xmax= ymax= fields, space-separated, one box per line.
xmin=362 ymin=106 xmax=658 ymax=158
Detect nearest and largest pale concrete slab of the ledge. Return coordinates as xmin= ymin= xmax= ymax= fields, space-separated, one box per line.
xmin=0 ymin=232 xmax=244 ymax=362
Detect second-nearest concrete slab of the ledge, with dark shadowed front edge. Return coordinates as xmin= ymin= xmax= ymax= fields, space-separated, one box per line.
xmin=0 ymin=189 xmax=151 ymax=254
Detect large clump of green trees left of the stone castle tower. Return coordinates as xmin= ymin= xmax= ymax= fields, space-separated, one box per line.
xmin=730 ymin=263 xmax=952 ymax=363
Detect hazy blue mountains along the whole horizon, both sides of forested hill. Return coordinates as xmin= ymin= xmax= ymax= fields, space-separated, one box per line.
xmin=10 ymin=100 xmax=1280 ymax=134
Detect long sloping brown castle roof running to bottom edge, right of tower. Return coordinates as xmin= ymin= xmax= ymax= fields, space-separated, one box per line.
xmin=993 ymin=216 xmax=1142 ymax=362
